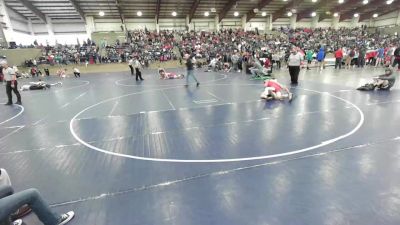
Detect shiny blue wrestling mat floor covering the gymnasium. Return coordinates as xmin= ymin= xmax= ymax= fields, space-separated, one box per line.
xmin=0 ymin=68 xmax=400 ymax=225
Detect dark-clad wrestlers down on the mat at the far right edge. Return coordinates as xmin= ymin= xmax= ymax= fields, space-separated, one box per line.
xmin=357 ymin=67 xmax=396 ymax=91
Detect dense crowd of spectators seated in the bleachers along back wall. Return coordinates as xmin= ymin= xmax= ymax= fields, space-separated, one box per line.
xmin=3 ymin=26 xmax=400 ymax=73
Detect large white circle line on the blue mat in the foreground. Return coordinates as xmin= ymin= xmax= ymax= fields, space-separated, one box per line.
xmin=69 ymin=87 xmax=365 ymax=163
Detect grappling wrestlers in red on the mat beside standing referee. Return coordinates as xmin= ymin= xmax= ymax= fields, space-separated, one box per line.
xmin=260 ymin=79 xmax=293 ymax=101
